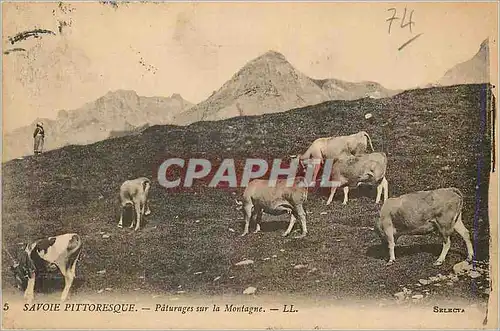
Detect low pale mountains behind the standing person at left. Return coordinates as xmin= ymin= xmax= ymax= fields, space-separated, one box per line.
xmin=3 ymin=90 xmax=192 ymax=160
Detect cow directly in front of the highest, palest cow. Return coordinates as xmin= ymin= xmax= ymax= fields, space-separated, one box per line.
xmin=326 ymin=152 xmax=389 ymax=205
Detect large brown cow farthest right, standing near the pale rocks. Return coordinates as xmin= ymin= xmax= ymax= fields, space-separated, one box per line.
xmin=375 ymin=187 xmax=474 ymax=265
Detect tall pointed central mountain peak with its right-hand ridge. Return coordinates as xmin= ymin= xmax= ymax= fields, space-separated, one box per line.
xmin=173 ymin=51 xmax=397 ymax=125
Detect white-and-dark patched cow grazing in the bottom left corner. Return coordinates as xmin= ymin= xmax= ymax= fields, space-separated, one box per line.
xmin=11 ymin=233 xmax=82 ymax=303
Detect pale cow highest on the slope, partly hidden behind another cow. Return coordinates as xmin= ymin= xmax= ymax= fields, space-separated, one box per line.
xmin=299 ymin=131 xmax=374 ymax=181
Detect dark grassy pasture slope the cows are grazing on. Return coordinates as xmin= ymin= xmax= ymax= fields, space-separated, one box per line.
xmin=2 ymin=85 xmax=489 ymax=298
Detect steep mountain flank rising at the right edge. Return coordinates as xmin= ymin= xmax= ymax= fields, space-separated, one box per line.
xmin=438 ymin=39 xmax=490 ymax=86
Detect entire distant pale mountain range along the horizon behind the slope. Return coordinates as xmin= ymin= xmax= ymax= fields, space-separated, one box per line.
xmin=3 ymin=39 xmax=489 ymax=160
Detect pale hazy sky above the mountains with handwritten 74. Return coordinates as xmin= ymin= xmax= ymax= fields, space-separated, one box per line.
xmin=2 ymin=2 xmax=498 ymax=132
